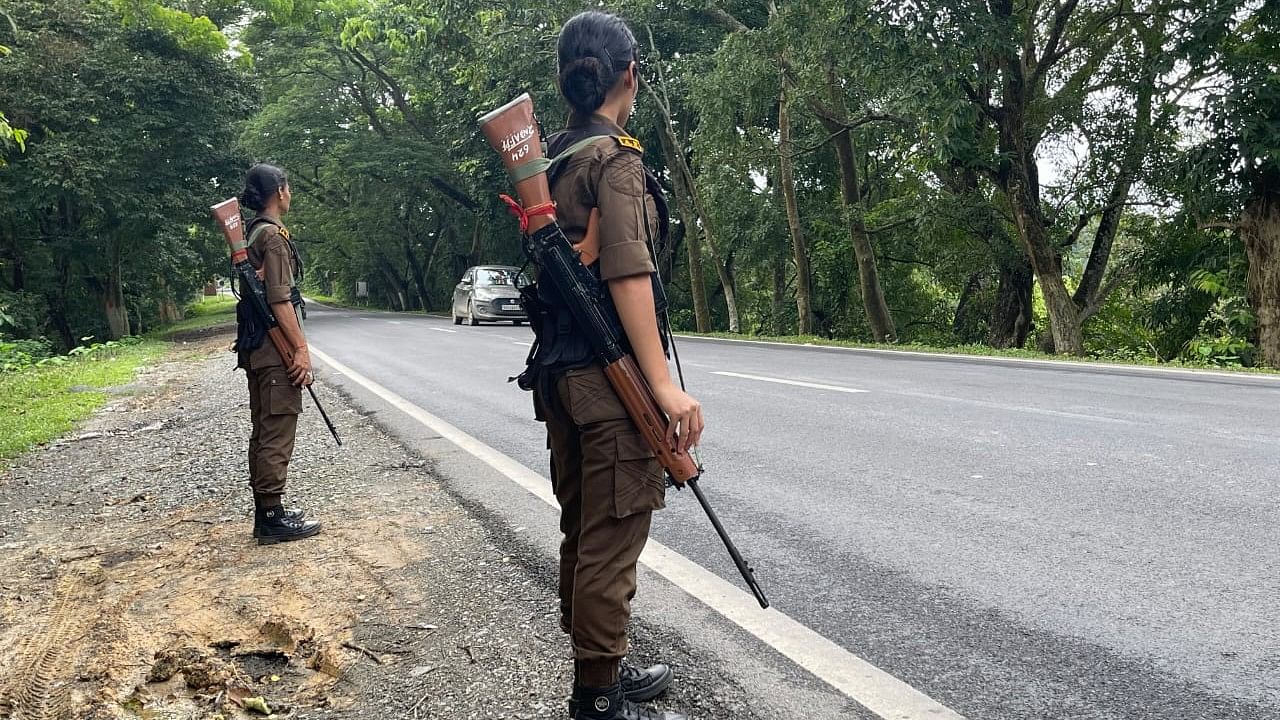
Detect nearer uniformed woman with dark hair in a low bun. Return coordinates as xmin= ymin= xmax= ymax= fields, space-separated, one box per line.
xmin=530 ymin=12 xmax=703 ymax=720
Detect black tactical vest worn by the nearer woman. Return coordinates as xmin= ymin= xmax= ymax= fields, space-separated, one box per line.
xmin=518 ymin=123 xmax=671 ymax=397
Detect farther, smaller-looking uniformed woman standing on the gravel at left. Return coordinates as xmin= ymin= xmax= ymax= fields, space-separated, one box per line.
xmin=237 ymin=165 xmax=320 ymax=544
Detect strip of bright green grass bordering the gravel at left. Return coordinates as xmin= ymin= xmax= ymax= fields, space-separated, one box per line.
xmin=0 ymin=297 xmax=236 ymax=468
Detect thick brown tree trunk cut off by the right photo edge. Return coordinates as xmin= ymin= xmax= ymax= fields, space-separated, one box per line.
xmin=1240 ymin=193 xmax=1280 ymax=368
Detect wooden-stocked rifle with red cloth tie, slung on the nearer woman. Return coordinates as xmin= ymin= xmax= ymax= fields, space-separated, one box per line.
xmin=480 ymin=94 xmax=769 ymax=607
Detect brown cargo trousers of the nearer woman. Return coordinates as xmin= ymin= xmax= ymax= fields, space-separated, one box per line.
xmin=534 ymin=365 xmax=666 ymax=688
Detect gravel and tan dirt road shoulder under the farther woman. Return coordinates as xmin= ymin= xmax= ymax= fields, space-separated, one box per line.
xmin=0 ymin=336 xmax=756 ymax=720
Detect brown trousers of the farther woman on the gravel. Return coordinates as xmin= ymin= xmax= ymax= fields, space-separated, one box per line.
xmin=244 ymin=365 xmax=302 ymax=507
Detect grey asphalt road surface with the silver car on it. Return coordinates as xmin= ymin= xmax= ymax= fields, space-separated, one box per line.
xmin=307 ymin=304 xmax=1280 ymax=720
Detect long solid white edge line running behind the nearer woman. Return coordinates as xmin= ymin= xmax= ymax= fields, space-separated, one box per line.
xmin=311 ymin=346 xmax=964 ymax=720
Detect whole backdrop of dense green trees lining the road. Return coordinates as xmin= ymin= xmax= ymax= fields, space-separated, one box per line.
xmin=0 ymin=0 xmax=1280 ymax=366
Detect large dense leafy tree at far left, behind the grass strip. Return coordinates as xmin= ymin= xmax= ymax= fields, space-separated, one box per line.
xmin=0 ymin=0 xmax=248 ymax=346
